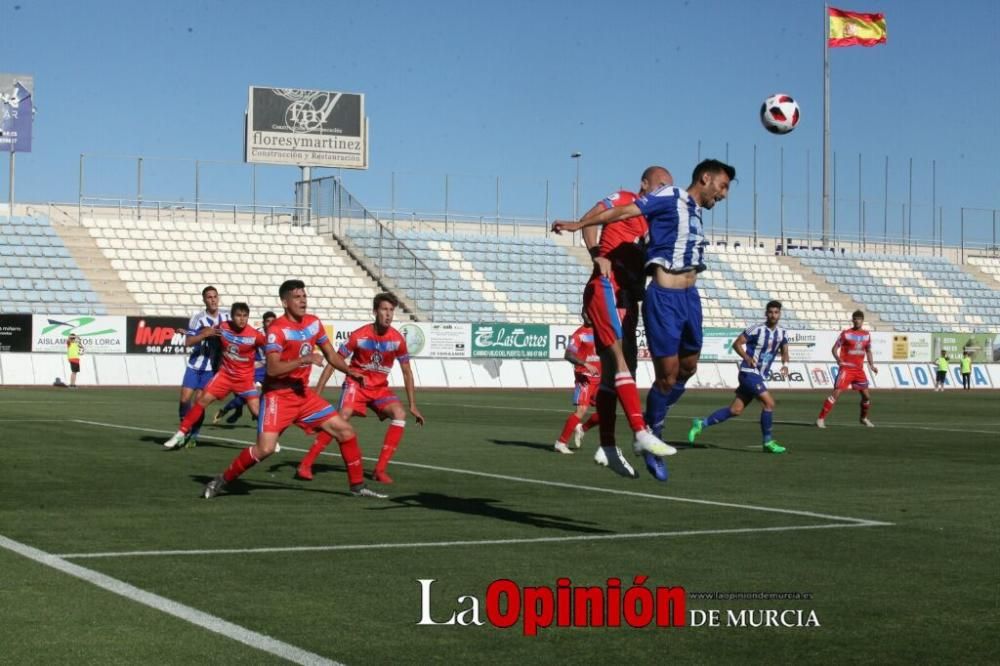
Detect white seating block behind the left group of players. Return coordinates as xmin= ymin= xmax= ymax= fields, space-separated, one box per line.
xmin=76 ymin=217 xmax=379 ymax=319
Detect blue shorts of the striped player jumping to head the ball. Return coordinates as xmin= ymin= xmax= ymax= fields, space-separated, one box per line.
xmin=642 ymin=282 xmax=702 ymax=358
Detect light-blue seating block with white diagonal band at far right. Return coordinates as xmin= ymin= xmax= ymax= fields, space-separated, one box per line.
xmin=791 ymin=250 xmax=1000 ymax=332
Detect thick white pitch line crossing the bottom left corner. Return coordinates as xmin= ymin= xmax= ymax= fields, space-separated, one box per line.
xmin=0 ymin=535 xmax=341 ymax=666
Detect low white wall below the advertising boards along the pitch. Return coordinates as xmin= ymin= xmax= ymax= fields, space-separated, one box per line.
xmin=0 ymin=352 xmax=1000 ymax=390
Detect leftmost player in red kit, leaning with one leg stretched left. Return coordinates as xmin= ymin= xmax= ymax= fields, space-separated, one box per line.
xmin=163 ymin=303 xmax=264 ymax=449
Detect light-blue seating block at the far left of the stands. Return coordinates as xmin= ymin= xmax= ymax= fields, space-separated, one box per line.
xmin=0 ymin=215 xmax=107 ymax=314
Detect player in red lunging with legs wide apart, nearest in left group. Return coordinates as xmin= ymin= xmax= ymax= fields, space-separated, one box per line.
xmin=202 ymin=280 xmax=385 ymax=499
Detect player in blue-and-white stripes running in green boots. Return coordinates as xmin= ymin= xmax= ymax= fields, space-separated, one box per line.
xmin=688 ymin=301 xmax=788 ymax=453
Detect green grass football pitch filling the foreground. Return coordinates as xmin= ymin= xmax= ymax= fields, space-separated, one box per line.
xmin=0 ymin=388 xmax=1000 ymax=664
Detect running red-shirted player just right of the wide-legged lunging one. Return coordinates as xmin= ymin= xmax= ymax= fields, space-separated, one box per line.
xmin=298 ymin=293 xmax=424 ymax=483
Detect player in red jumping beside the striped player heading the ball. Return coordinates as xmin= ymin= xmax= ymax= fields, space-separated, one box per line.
xmin=552 ymin=166 xmax=674 ymax=478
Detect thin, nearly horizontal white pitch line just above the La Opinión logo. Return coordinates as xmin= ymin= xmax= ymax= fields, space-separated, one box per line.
xmin=57 ymin=521 xmax=886 ymax=560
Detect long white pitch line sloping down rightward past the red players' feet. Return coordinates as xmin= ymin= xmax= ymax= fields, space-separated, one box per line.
xmin=74 ymin=419 xmax=892 ymax=526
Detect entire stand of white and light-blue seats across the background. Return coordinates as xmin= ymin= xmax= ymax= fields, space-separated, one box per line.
xmin=7 ymin=208 xmax=1000 ymax=332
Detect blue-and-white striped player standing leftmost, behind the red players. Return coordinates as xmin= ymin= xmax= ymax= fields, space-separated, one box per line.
xmin=178 ymin=286 xmax=230 ymax=446
